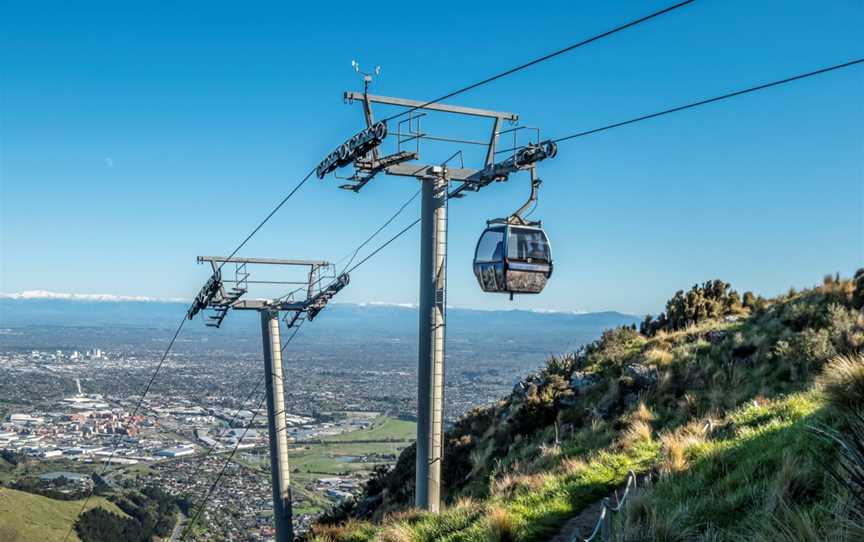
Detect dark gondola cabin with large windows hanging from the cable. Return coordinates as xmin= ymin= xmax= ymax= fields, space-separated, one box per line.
xmin=474 ymin=222 xmax=552 ymax=299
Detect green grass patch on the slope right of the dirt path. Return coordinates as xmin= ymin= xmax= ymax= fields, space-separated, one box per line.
xmin=628 ymin=392 xmax=848 ymax=540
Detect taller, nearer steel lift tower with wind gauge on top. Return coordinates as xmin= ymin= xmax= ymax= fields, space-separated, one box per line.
xmin=316 ymin=70 xmax=557 ymax=512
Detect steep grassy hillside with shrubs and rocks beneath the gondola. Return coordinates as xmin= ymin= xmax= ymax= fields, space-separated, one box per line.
xmin=310 ymin=271 xmax=864 ymax=542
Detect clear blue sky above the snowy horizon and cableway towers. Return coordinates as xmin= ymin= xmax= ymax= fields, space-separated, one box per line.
xmin=0 ymin=0 xmax=864 ymax=313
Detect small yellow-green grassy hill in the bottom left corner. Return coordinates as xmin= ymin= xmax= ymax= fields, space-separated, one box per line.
xmin=0 ymin=487 xmax=127 ymax=542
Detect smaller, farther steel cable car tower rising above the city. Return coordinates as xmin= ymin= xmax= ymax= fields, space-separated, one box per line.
xmin=186 ymin=256 xmax=349 ymax=542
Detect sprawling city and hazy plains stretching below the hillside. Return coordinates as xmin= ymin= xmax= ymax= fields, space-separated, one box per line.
xmin=0 ymin=299 xmax=633 ymax=540
